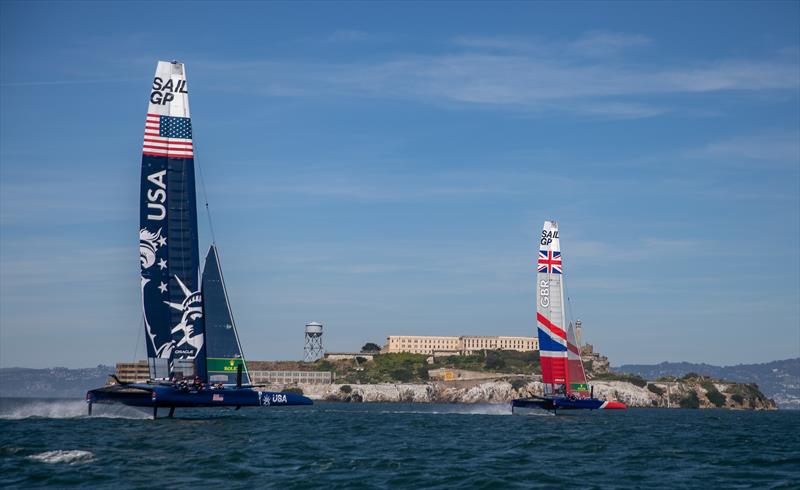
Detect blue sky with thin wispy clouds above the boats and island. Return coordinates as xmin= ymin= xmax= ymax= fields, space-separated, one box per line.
xmin=0 ymin=1 xmax=800 ymax=367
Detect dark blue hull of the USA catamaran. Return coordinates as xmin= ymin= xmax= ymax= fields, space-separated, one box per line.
xmin=86 ymin=384 xmax=314 ymax=408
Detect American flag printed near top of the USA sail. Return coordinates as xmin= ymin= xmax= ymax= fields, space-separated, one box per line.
xmin=142 ymin=114 xmax=194 ymax=158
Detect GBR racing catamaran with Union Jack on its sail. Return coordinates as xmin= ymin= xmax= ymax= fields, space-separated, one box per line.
xmin=511 ymin=221 xmax=626 ymax=414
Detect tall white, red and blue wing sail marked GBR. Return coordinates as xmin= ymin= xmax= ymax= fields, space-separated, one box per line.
xmin=536 ymin=221 xmax=567 ymax=392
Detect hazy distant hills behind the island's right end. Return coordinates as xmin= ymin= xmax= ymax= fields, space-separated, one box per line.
xmin=612 ymin=357 xmax=800 ymax=409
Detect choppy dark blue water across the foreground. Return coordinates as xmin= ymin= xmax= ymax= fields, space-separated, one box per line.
xmin=0 ymin=399 xmax=800 ymax=490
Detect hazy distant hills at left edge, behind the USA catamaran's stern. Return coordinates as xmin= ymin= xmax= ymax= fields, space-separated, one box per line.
xmin=0 ymin=365 xmax=114 ymax=398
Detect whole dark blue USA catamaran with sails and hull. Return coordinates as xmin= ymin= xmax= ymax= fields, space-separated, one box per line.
xmin=86 ymin=61 xmax=312 ymax=417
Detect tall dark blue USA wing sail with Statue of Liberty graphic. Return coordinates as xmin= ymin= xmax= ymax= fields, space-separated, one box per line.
xmin=139 ymin=61 xmax=206 ymax=379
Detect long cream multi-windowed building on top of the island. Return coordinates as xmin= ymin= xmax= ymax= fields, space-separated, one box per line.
xmin=381 ymin=335 xmax=539 ymax=356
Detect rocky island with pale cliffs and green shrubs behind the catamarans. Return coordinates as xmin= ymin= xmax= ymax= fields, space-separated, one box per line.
xmin=250 ymin=345 xmax=776 ymax=410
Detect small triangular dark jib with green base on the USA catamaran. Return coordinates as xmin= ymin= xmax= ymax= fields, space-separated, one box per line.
xmin=203 ymin=245 xmax=250 ymax=384
